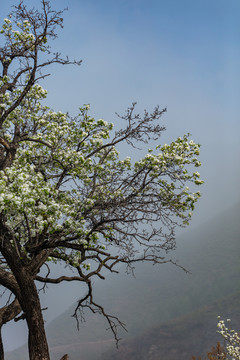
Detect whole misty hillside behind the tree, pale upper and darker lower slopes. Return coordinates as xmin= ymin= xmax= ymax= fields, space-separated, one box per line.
xmin=7 ymin=204 xmax=240 ymax=360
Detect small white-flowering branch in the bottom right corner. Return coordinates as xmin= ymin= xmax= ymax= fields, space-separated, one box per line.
xmin=217 ymin=317 xmax=240 ymax=360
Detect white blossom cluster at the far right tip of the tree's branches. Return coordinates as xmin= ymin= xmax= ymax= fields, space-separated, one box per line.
xmin=135 ymin=134 xmax=203 ymax=224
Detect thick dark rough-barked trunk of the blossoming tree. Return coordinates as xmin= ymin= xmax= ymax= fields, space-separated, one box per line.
xmin=0 ymin=229 xmax=50 ymax=360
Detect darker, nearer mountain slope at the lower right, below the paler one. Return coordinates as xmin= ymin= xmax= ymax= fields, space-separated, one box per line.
xmin=101 ymin=291 xmax=240 ymax=360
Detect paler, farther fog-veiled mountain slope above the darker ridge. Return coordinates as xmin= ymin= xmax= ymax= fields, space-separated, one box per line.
xmin=8 ymin=204 xmax=240 ymax=360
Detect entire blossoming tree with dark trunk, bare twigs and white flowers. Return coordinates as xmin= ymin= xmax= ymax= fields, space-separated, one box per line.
xmin=0 ymin=0 xmax=203 ymax=360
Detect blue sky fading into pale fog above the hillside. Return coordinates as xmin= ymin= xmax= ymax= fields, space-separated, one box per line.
xmin=0 ymin=0 xmax=240 ymax=348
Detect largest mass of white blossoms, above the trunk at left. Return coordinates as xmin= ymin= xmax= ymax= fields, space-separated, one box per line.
xmin=0 ymin=85 xmax=119 ymax=252
